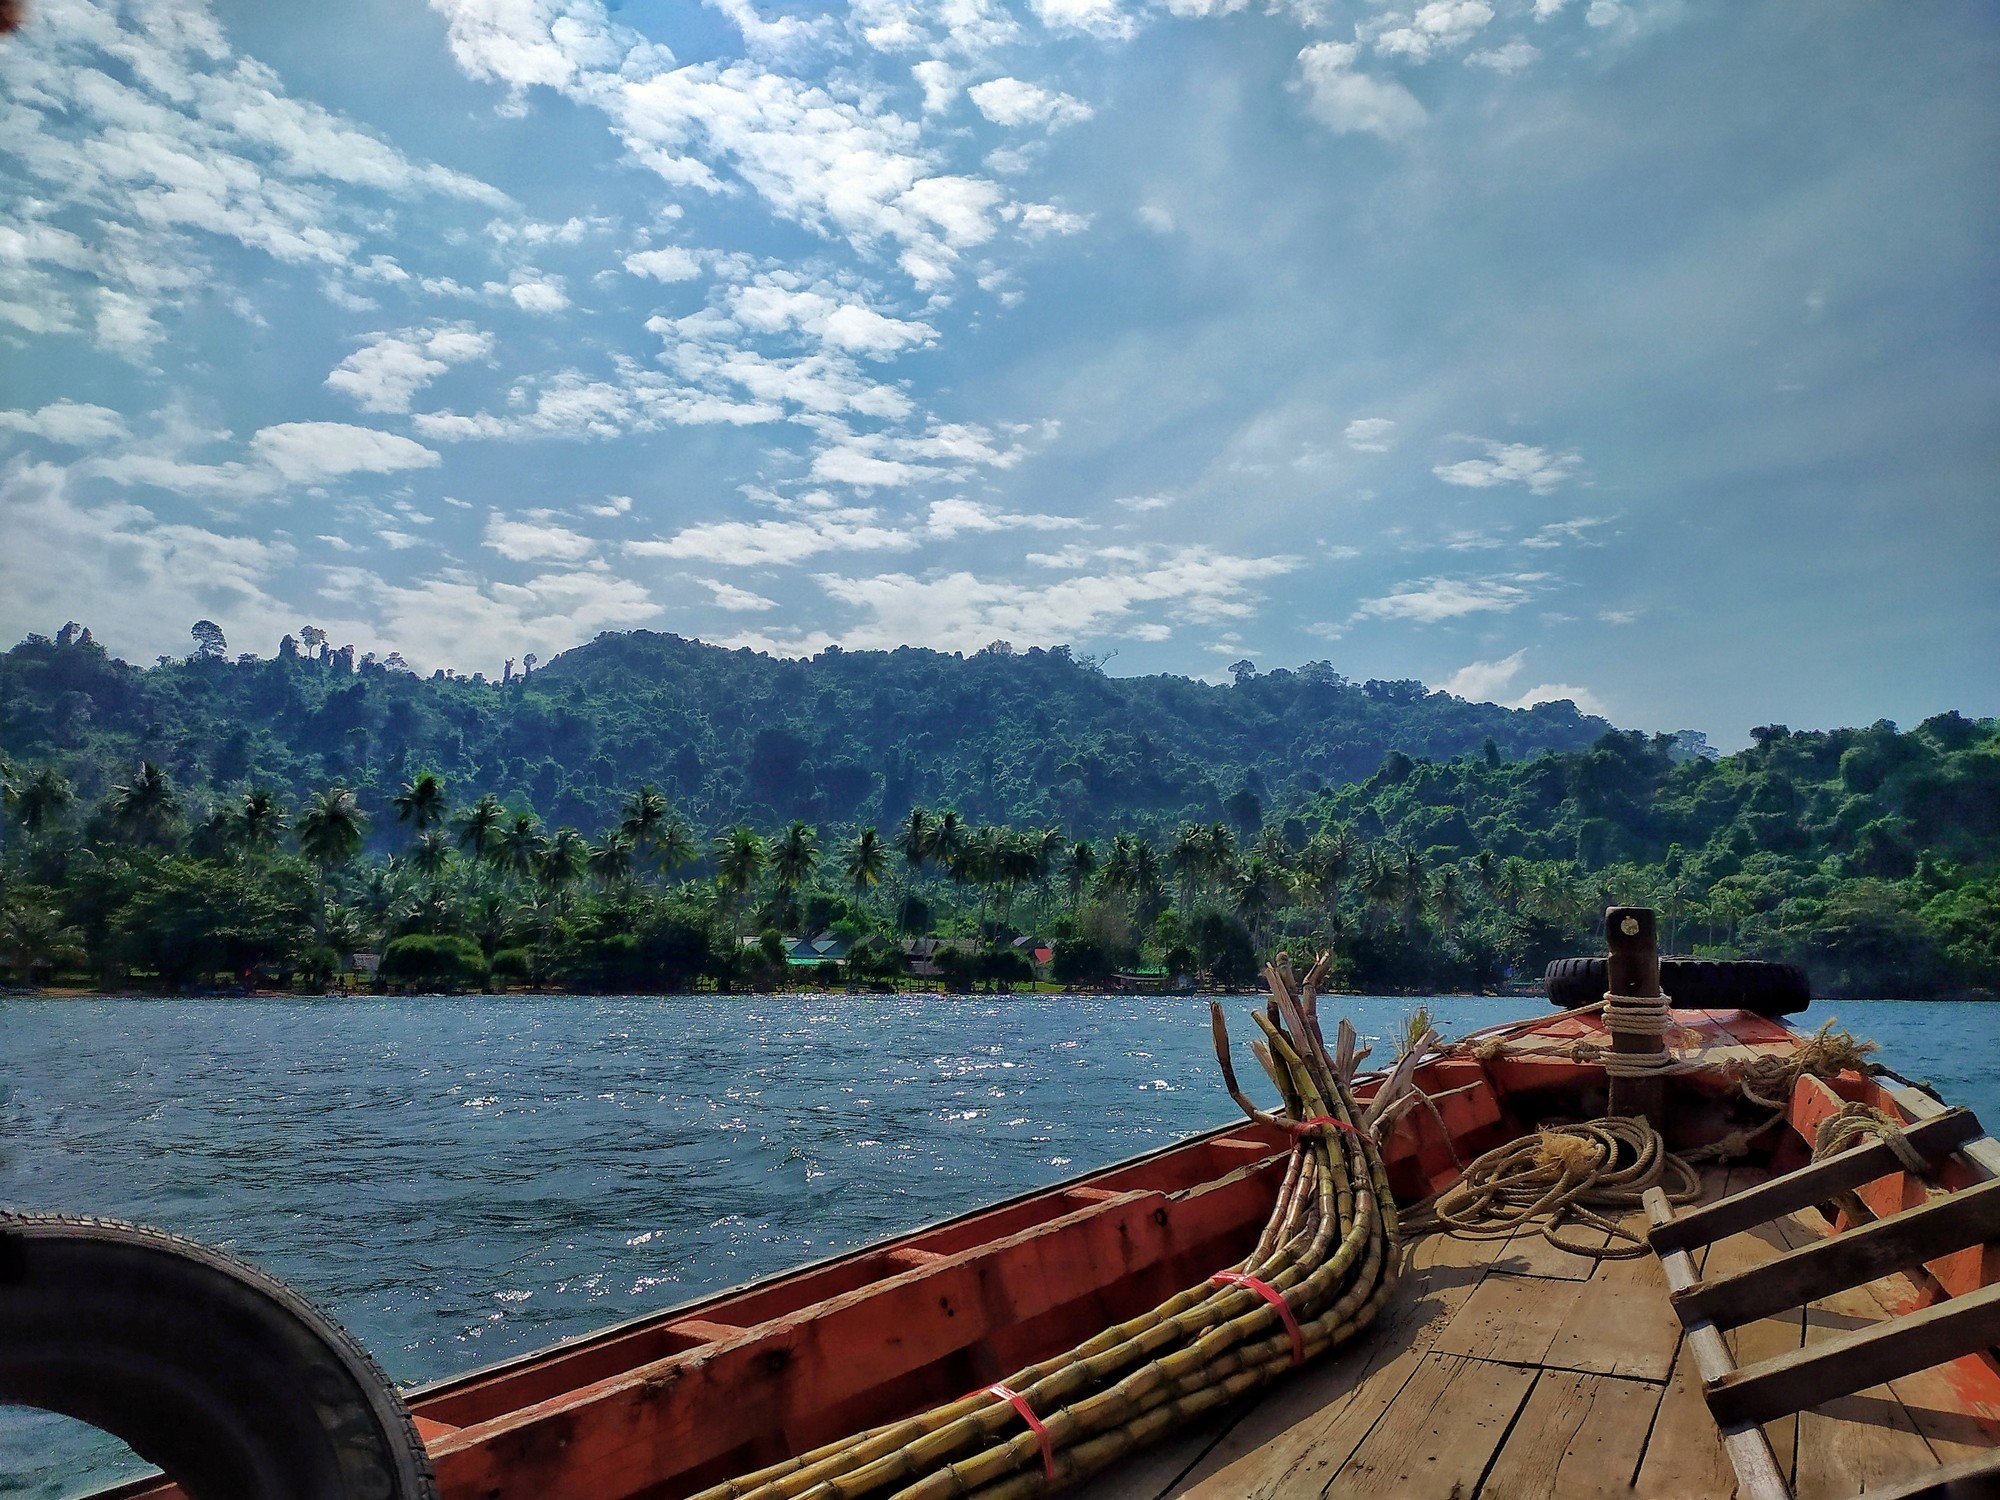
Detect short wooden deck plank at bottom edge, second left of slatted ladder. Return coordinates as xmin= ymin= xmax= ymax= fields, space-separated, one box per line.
xmin=1480 ymin=1370 xmax=1662 ymax=1500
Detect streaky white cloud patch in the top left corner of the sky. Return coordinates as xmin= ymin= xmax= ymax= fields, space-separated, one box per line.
xmin=0 ymin=2 xmax=508 ymax=360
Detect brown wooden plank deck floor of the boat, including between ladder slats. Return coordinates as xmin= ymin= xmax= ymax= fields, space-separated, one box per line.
xmin=1076 ymin=1168 xmax=2000 ymax=1500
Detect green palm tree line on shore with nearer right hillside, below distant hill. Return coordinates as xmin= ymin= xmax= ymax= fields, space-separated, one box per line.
xmin=0 ymin=714 xmax=2000 ymax=996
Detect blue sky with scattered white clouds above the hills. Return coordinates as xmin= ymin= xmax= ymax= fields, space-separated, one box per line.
xmin=0 ymin=0 xmax=2000 ymax=746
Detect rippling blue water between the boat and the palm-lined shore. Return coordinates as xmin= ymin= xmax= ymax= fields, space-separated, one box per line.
xmin=0 ymin=996 xmax=2000 ymax=1498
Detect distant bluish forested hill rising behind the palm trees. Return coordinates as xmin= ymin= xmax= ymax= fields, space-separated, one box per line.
xmin=0 ymin=630 xmax=1610 ymax=838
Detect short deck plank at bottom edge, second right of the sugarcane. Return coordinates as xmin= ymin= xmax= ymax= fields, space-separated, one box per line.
xmin=1324 ymin=1350 xmax=1536 ymax=1500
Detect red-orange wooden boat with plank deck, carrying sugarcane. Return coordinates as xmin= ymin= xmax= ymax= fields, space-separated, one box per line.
xmin=90 ymin=916 xmax=2000 ymax=1500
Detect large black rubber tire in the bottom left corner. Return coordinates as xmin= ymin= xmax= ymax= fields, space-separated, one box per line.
xmin=0 ymin=1214 xmax=438 ymax=1500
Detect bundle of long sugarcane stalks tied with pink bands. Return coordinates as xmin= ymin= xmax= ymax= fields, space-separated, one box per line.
xmin=696 ymin=954 xmax=1436 ymax=1500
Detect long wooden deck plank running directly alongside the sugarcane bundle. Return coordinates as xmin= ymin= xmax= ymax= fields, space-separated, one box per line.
xmin=1152 ymin=1234 xmax=1492 ymax=1500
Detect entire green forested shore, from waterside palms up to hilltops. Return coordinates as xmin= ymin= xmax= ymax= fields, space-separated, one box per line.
xmin=0 ymin=630 xmax=2000 ymax=996
